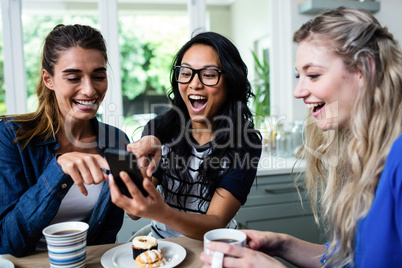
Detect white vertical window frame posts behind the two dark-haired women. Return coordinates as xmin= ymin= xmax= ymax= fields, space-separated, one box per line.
xmin=1 ymin=0 xmax=206 ymax=128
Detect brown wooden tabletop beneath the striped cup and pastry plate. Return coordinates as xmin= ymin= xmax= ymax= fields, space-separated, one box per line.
xmin=0 ymin=237 xmax=203 ymax=268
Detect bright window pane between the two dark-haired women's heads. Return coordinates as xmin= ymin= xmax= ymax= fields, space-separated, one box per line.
xmin=119 ymin=11 xmax=189 ymax=140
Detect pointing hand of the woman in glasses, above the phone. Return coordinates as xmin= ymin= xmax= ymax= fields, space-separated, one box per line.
xmin=127 ymin=135 xmax=162 ymax=177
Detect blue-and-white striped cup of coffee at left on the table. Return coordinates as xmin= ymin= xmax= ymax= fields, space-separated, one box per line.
xmin=42 ymin=221 xmax=89 ymax=268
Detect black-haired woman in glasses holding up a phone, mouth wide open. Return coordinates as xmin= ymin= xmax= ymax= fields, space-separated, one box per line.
xmin=110 ymin=32 xmax=261 ymax=239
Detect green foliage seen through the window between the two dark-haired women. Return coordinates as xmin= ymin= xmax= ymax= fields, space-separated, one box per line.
xmin=119 ymin=16 xmax=188 ymax=100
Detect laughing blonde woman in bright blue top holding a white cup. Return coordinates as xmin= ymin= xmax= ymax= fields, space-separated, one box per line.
xmin=201 ymin=7 xmax=402 ymax=267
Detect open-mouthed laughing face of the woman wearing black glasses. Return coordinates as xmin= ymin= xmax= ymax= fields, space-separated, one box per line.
xmin=179 ymin=44 xmax=227 ymax=128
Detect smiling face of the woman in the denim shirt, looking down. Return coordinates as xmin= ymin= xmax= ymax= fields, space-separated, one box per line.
xmin=42 ymin=47 xmax=108 ymax=123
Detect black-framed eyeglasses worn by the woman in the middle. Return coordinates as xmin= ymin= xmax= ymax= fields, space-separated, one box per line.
xmin=173 ymin=66 xmax=225 ymax=86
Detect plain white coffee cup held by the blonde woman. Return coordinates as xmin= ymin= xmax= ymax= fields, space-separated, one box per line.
xmin=204 ymin=228 xmax=247 ymax=268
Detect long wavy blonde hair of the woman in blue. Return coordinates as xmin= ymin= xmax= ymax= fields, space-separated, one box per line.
xmin=293 ymin=7 xmax=402 ymax=267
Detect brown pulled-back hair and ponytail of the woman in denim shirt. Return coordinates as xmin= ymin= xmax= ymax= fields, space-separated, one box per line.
xmin=0 ymin=24 xmax=107 ymax=148
